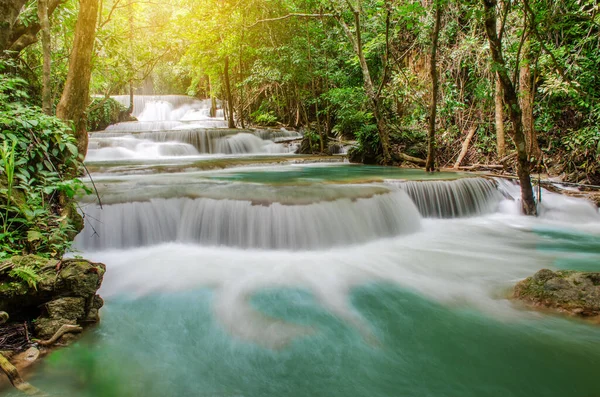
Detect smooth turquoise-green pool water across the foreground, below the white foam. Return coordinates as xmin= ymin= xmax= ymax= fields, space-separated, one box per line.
xmin=21 ymin=284 xmax=600 ymax=397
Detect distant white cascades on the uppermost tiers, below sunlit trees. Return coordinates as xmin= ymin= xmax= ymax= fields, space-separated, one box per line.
xmin=86 ymin=95 xmax=300 ymax=162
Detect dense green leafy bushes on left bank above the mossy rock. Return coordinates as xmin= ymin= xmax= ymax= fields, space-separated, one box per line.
xmin=0 ymin=75 xmax=89 ymax=256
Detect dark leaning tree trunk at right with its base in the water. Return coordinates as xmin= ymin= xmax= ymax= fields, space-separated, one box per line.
xmin=482 ymin=0 xmax=537 ymax=215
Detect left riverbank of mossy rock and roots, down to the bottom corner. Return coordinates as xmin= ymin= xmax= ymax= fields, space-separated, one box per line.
xmin=0 ymin=255 xmax=106 ymax=394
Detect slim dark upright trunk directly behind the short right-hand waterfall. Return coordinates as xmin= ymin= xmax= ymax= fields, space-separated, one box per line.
xmin=425 ymin=0 xmax=442 ymax=172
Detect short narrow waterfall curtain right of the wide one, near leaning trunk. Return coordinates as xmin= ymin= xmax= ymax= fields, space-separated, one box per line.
xmin=388 ymin=178 xmax=503 ymax=218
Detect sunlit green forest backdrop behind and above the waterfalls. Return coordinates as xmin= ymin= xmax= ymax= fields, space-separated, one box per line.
xmin=0 ymin=0 xmax=600 ymax=184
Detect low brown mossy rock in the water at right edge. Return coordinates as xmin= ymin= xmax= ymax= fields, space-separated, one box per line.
xmin=514 ymin=269 xmax=600 ymax=319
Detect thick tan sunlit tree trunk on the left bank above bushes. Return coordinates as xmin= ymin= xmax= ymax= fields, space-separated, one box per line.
xmin=56 ymin=0 xmax=98 ymax=156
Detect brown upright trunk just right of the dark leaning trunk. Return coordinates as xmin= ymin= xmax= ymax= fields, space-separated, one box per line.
xmin=519 ymin=38 xmax=541 ymax=159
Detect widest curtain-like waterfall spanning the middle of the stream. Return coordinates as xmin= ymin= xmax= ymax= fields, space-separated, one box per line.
xmin=76 ymin=191 xmax=420 ymax=250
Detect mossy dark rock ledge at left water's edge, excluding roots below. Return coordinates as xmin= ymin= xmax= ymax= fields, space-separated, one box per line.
xmin=0 ymin=255 xmax=106 ymax=342
